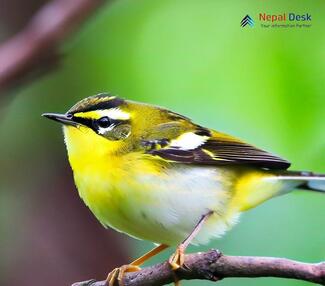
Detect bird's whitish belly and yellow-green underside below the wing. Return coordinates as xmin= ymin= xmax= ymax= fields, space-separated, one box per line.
xmin=82 ymin=166 xmax=239 ymax=245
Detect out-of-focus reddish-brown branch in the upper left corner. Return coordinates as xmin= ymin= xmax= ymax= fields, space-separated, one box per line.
xmin=0 ymin=0 xmax=104 ymax=90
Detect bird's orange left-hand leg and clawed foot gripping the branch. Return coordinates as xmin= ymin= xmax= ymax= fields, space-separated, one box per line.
xmin=106 ymin=244 xmax=168 ymax=286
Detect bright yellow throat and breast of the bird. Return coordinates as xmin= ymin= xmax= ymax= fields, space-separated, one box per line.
xmin=64 ymin=127 xmax=159 ymax=235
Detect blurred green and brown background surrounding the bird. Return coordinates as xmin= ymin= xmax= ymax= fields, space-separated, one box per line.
xmin=0 ymin=0 xmax=325 ymax=286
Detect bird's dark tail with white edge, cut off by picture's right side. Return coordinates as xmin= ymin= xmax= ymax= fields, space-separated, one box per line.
xmin=279 ymin=171 xmax=325 ymax=194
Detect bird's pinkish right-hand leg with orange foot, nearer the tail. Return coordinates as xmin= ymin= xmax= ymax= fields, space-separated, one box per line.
xmin=168 ymin=211 xmax=213 ymax=270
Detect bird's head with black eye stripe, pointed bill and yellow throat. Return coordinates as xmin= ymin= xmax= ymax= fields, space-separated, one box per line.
xmin=43 ymin=93 xmax=140 ymax=165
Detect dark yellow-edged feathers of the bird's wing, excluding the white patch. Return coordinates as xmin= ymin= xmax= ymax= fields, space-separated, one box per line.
xmin=146 ymin=129 xmax=290 ymax=169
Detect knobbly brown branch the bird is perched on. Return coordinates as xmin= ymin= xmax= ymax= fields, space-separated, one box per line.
xmin=73 ymin=250 xmax=325 ymax=286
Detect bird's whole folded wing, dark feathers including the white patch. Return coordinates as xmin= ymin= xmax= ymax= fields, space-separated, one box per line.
xmin=143 ymin=126 xmax=290 ymax=169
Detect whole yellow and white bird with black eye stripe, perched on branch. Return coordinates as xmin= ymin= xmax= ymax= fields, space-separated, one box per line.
xmin=42 ymin=93 xmax=325 ymax=286
